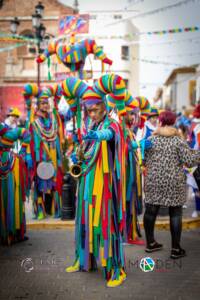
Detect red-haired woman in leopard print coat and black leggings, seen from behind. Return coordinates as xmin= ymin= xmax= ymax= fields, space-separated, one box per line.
xmin=144 ymin=111 xmax=200 ymax=258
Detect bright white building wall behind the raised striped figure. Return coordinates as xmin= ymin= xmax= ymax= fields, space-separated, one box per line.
xmin=82 ymin=12 xmax=139 ymax=96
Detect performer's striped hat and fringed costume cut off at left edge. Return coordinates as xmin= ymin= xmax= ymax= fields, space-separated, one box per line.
xmin=0 ymin=124 xmax=30 ymax=244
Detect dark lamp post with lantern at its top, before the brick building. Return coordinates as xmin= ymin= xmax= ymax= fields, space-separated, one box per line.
xmin=32 ymin=2 xmax=46 ymax=86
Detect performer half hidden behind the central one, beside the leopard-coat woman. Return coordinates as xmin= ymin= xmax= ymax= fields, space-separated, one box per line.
xmin=107 ymin=91 xmax=151 ymax=245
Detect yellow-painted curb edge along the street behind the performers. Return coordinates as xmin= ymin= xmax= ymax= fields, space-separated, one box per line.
xmin=26 ymin=218 xmax=200 ymax=230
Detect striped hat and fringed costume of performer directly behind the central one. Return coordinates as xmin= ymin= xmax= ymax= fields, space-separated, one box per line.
xmin=107 ymin=91 xmax=143 ymax=244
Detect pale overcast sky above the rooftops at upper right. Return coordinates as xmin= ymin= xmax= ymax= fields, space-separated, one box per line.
xmin=60 ymin=0 xmax=200 ymax=99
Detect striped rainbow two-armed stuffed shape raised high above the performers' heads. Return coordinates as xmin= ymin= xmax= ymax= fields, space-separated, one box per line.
xmin=37 ymin=39 xmax=112 ymax=77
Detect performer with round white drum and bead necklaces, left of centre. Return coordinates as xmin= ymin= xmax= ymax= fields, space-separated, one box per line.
xmin=24 ymin=84 xmax=63 ymax=219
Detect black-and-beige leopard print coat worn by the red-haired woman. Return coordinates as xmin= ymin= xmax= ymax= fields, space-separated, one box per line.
xmin=144 ymin=136 xmax=200 ymax=206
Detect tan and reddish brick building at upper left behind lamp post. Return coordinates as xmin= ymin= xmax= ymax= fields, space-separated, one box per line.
xmin=0 ymin=0 xmax=73 ymax=118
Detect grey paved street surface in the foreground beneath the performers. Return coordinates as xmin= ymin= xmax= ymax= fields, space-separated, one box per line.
xmin=0 ymin=228 xmax=200 ymax=300
